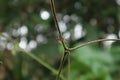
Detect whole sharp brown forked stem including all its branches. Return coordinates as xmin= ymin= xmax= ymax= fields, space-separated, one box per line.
xmin=50 ymin=0 xmax=120 ymax=80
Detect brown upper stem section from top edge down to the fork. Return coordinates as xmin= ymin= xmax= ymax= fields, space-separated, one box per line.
xmin=50 ymin=0 xmax=67 ymax=49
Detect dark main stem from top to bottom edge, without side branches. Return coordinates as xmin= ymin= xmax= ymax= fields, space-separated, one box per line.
xmin=50 ymin=0 xmax=68 ymax=80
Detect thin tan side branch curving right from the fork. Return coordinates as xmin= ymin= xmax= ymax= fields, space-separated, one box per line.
xmin=69 ymin=39 xmax=120 ymax=51
